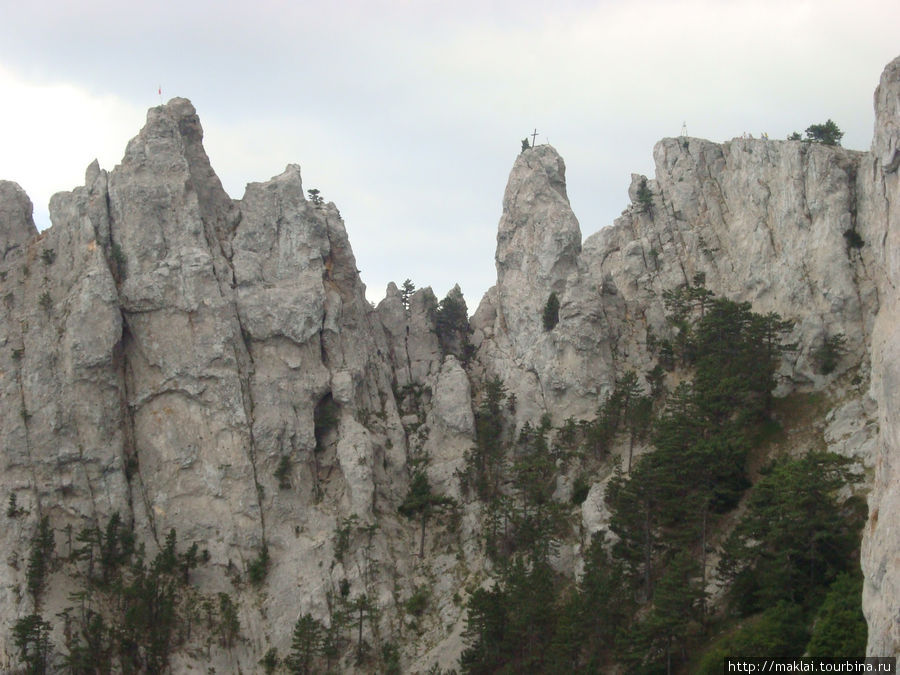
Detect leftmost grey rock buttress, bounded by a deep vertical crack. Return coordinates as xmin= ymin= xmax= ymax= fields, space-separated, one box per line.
xmin=0 ymin=160 xmax=129 ymax=668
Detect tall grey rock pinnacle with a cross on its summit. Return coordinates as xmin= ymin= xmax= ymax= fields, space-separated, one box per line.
xmin=473 ymin=145 xmax=612 ymax=428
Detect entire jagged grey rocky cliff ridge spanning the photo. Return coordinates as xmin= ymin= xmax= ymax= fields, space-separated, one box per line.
xmin=0 ymin=59 xmax=900 ymax=672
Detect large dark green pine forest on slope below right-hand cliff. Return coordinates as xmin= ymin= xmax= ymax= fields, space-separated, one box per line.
xmin=460 ymin=282 xmax=865 ymax=673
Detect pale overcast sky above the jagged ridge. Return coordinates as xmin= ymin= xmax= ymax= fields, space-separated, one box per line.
xmin=0 ymin=0 xmax=900 ymax=311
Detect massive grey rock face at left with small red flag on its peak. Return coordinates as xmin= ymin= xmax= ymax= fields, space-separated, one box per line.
xmin=0 ymin=99 xmax=414 ymax=671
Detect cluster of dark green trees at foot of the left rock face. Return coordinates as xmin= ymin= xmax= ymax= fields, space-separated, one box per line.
xmin=7 ymin=513 xmax=230 ymax=673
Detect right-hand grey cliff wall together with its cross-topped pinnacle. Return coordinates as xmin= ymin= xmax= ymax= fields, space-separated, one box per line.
xmin=472 ymin=62 xmax=900 ymax=654
